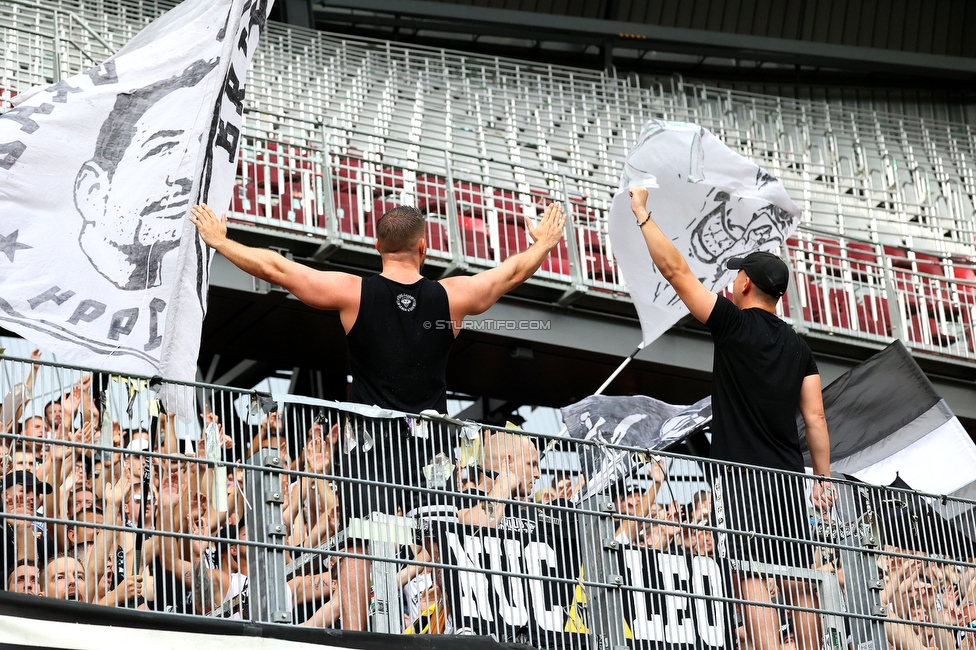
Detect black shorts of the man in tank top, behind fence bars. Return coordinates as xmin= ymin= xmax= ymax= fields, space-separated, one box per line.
xmin=333 ymin=418 xmax=456 ymax=525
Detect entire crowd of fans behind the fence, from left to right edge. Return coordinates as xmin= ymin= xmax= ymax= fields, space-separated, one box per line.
xmin=0 ymin=354 xmax=976 ymax=650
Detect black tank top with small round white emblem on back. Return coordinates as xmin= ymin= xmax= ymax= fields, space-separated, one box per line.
xmin=347 ymin=275 xmax=454 ymax=413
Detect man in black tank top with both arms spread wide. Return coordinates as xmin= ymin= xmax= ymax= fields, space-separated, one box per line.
xmin=190 ymin=203 xmax=566 ymax=629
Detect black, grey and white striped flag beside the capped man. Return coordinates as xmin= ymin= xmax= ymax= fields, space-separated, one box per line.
xmin=797 ymin=340 xmax=976 ymax=495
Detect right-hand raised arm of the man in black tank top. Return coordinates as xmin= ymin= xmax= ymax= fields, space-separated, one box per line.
xmin=441 ymin=203 xmax=566 ymax=333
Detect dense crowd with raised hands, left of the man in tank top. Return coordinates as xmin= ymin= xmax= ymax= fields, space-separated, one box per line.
xmin=0 ymin=355 xmax=348 ymax=625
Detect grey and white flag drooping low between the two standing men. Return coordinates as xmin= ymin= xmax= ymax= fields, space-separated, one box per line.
xmin=562 ymin=395 xmax=712 ymax=494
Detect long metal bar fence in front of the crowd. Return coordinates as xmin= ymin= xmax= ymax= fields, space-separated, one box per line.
xmin=0 ymin=358 xmax=976 ymax=650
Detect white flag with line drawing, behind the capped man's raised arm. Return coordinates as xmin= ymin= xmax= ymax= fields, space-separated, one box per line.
xmin=610 ymin=120 xmax=800 ymax=345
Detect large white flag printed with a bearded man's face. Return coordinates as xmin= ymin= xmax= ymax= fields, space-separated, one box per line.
xmin=0 ymin=0 xmax=270 ymax=380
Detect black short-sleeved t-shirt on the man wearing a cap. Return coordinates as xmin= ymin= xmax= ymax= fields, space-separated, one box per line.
xmin=705 ymin=296 xmax=818 ymax=472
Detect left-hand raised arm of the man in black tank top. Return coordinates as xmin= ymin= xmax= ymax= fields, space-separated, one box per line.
xmin=190 ymin=205 xmax=362 ymax=322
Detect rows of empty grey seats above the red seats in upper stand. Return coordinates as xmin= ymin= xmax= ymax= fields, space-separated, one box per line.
xmin=0 ymin=2 xmax=976 ymax=257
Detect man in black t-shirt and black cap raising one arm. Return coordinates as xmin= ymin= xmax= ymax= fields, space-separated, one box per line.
xmin=630 ymin=187 xmax=833 ymax=650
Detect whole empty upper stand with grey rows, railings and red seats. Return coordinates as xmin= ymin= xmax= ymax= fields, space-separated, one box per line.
xmin=0 ymin=0 xmax=976 ymax=360
